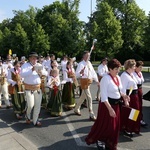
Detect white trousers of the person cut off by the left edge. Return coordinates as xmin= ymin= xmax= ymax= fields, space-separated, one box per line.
xmin=0 ymin=82 xmax=10 ymax=106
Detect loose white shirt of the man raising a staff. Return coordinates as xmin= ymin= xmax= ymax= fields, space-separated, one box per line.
xmin=76 ymin=60 xmax=98 ymax=82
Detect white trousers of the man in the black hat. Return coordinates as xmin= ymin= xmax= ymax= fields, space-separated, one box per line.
xmin=25 ymin=90 xmax=42 ymax=125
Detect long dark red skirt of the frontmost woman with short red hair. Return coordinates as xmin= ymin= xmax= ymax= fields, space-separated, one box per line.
xmin=85 ymin=102 xmax=120 ymax=150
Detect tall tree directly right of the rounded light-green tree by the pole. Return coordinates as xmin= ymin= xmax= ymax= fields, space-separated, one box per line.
xmin=97 ymin=0 xmax=146 ymax=60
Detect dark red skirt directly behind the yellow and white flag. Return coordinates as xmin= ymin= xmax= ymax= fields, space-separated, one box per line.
xmin=120 ymin=94 xmax=141 ymax=134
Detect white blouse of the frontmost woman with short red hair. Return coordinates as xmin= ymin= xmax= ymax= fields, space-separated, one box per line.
xmin=100 ymin=74 xmax=122 ymax=102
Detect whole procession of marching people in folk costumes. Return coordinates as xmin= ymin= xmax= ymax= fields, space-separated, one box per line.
xmin=0 ymin=51 xmax=147 ymax=150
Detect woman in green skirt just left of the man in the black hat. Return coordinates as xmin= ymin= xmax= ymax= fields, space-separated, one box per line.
xmin=7 ymin=61 xmax=26 ymax=119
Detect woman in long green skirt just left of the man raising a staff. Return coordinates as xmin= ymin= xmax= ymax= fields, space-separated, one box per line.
xmin=62 ymin=61 xmax=76 ymax=109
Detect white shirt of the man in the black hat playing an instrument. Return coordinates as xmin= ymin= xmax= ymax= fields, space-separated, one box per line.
xmin=20 ymin=63 xmax=47 ymax=85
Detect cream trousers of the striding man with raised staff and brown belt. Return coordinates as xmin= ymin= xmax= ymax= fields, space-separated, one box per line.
xmin=75 ymin=86 xmax=94 ymax=115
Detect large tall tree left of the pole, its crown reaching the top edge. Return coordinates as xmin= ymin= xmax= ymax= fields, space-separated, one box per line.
xmin=36 ymin=1 xmax=82 ymax=56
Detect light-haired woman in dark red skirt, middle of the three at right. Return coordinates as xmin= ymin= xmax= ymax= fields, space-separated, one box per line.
xmin=121 ymin=59 xmax=141 ymax=137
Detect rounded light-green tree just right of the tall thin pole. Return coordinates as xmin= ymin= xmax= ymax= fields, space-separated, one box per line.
xmin=96 ymin=2 xmax=123 ymax=57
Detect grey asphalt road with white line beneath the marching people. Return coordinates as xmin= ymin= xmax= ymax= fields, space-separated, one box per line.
xmin=0 ymin=73 xmax=150 ymax=150
